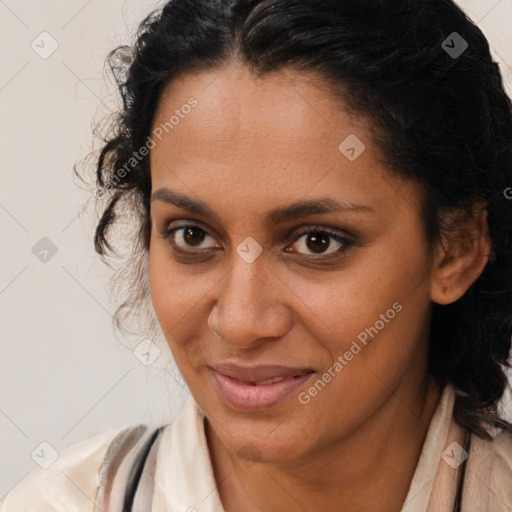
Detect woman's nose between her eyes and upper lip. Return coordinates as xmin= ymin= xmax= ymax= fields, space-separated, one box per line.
xmin=208 ymin=255 xmax=292 ymax=349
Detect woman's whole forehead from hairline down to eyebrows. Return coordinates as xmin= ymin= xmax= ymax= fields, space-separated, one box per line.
xmin=151 ymin=64 xmax=420 ymax=218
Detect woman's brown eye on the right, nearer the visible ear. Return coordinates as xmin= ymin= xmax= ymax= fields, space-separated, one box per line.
xmin=285 ymin=226 xmax=353 ymax=258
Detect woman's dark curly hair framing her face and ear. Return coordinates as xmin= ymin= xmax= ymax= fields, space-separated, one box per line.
xmin=86 ymin=0 xmax=512 ymax=438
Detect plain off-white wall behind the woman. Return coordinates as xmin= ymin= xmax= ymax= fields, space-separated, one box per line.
xmin=0 ymin=0 xmax=512 ymax=499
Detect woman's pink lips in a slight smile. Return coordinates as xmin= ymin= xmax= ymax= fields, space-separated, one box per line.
xmin=210 ymin=365 xmax=315 ymax=411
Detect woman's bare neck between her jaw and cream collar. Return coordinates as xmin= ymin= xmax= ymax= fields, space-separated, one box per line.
xmin=206 ymin=379 xmax=440 ymax=512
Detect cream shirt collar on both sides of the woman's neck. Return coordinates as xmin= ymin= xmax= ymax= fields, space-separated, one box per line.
xmin=152 ymin=385 xmax=455 ymax=512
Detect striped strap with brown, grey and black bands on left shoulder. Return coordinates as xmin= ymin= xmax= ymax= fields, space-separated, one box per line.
xmin=94 ymin=424 xmax=164 ymax=512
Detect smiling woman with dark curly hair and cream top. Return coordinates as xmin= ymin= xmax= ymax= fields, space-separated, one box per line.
xmin=2 ymin=0 xmax=512 ymax=512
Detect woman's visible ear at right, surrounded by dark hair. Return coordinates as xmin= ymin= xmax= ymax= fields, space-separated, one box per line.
xmin=430 ymin=202 xmax=491 ymax=304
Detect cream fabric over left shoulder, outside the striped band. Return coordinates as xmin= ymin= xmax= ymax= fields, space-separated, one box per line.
xmin=0 ymin=427 xmax=127 ymax=512
